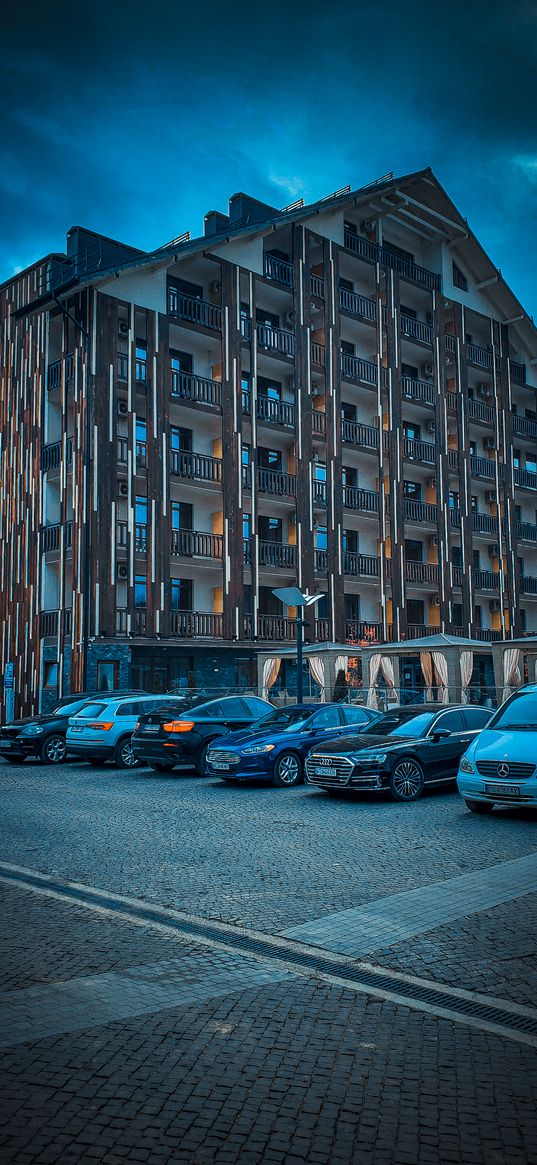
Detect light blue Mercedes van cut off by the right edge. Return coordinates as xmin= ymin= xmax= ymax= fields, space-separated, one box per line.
xmin=457 ymin=684 xmax=537 ymax=813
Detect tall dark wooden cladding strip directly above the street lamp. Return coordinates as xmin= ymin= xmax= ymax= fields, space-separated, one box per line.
xmin=292 ymin=225 xmax=313 ymax=610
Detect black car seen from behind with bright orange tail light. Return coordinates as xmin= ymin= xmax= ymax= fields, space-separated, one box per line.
xmin=133 ymin=696 xmax=274 ymax=776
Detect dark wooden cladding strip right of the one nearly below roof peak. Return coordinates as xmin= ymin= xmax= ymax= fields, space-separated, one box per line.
xmin=453 ymin=303 xmax=474 ymax=635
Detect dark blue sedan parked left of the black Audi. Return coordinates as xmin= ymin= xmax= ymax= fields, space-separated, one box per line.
xmin=205 ymin=704 xmax=379 ymax=789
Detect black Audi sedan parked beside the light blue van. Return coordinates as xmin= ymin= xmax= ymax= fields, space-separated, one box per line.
xmin=306 ymin=704 xmax=490 ymax=802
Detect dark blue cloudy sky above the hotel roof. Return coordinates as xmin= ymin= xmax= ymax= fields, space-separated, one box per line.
xmin=0 ymin=0 xmax=537 ymax=317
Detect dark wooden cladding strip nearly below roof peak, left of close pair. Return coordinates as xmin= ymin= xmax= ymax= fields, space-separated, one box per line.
xmin=433 ymin=295 xmax=453 ymax=633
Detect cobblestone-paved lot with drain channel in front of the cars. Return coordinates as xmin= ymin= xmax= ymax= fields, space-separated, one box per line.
xmin=0 ymin=763 xmax=537 ymax=1165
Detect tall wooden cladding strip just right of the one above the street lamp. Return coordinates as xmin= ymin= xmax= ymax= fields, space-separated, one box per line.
xmin=323 ymin=239 xmax=345 ymax=642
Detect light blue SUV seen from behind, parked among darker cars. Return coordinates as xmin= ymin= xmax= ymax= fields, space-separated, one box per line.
xmin=66 ymin=693 xmax=185 ymax=769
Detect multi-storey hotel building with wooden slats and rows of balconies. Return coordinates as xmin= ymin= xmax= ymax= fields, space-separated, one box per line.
xmin=0 ymin=163 xmax=537 ymax=712
